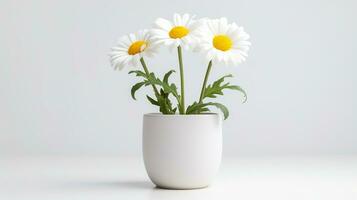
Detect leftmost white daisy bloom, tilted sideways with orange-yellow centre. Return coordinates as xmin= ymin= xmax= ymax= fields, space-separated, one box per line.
xmin=109 ymin=30 xmax=157 ymax=70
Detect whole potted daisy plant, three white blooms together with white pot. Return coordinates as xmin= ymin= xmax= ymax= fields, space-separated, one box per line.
xmin=110 ymin=14 xmax=250 ymax=189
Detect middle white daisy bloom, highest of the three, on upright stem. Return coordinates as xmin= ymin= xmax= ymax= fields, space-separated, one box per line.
xmin=151 ymin=13 xmax=201 ymax=49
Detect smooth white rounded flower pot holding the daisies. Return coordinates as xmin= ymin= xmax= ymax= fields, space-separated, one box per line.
xmin=143 ymin=113 xmax=222 ymax=189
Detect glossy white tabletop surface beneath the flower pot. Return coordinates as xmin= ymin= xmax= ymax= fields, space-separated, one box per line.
xmin=0 ymin=156 xmax=357 ymax=200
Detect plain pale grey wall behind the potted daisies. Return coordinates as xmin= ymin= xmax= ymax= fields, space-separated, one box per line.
xmin=0 ymin=0 xmax=357 ymax=155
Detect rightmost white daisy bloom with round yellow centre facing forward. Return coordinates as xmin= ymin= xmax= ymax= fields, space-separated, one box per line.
xmin=198 ymin=18 xmax=250 ymax=65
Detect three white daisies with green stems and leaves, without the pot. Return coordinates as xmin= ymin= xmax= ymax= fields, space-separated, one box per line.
xmin=110 ymin=14 xmax=250 ymax=119
